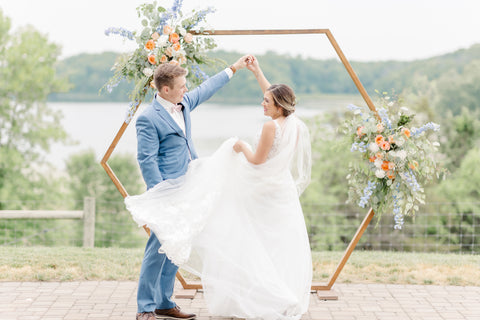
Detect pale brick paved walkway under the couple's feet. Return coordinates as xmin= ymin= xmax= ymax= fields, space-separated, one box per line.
xmin=0 ymin=281 xmax=480 ymax=320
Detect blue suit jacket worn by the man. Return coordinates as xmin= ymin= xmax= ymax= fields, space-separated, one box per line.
xmin=136 ymin=71 xmax=230 ymax=189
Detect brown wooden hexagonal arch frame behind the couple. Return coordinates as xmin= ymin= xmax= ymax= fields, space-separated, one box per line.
xmin=100 ymin=29 xmax=380 ymax=299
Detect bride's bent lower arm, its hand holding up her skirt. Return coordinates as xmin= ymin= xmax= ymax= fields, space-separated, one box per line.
xmin=233 ymin=121 xmax=275 ymax=164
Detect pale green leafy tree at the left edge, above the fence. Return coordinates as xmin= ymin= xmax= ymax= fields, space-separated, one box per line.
xmin=0 ymin=10 xmax=68 ymax=208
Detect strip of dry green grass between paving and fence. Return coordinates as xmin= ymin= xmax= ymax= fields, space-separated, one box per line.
xmin=0 ymin=247 xmax=480 ymax=286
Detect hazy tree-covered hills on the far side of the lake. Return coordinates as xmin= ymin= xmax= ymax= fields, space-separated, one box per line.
xmin=47 ymin=44 xmax=480 ymax=107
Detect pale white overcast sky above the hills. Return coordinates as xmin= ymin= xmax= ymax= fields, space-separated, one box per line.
xmin=0 ymin=0 xmax=480 ymax=61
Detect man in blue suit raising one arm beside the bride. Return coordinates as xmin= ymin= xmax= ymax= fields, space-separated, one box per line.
xmin=136 ymin=56 xmax=248 ymax=320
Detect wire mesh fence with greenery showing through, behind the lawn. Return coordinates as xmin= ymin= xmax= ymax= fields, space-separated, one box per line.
xmin=0 ymin=199 xmax=480 ymax=254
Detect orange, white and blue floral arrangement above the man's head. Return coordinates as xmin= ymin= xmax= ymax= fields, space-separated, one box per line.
xmin=102 ymin=0 xmax=216 ymax=107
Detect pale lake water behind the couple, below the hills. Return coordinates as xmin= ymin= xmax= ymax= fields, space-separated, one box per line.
xmin=47 ymin=101 xmax=360 ymax=170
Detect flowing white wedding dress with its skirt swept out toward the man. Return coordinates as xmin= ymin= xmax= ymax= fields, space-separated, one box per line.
xmin=125 ymin=114 xmax=312 ymax=320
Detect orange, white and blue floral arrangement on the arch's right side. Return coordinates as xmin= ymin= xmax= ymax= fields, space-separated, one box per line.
xmin=344 ymin=92 xmax=440 ymax=229
